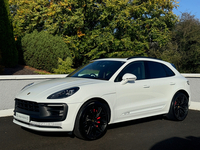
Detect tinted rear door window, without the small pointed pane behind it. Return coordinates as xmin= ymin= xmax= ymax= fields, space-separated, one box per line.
xmin=146 ymin=61 xmax=167 ymax=79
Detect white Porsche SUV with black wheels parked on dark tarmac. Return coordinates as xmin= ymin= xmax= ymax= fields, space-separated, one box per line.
xmin=13 ymin=57 xmax=191 ymax=140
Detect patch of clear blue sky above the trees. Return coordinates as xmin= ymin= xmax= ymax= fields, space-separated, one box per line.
xmin=173 ymin=0 xmax=200 ymax=20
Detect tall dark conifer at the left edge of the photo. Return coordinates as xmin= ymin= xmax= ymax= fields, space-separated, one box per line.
xmin=0 ymin=0 xmax=18 ymax=67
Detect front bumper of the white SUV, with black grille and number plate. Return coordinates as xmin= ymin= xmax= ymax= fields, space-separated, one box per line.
xmin=13 ymin=99 xmax=78 ymax=132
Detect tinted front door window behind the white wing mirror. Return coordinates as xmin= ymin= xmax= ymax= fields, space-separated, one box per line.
xmin=115 ymin=61 xmax=145 ymax=82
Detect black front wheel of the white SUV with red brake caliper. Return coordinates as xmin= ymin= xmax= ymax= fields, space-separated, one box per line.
xmin=74 ymin=101 xmax=108 ymax=140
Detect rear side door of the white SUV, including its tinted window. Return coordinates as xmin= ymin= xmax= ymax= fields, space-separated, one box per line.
xmin=145 ymin=61 xmax=176 ymax=113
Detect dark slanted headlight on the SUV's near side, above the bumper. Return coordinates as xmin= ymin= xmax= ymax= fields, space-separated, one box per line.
xmin=47 ymin=87 xmax=79 ymax=99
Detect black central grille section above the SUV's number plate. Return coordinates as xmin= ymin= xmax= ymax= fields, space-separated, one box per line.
xmin=15 ymin=99 xmax=39 ymax=112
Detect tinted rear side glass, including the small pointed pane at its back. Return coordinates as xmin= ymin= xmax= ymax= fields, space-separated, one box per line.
xmin=146 ymin=61 xmax=175 ymax=79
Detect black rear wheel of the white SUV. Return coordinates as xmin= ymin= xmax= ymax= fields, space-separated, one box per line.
xmin=167 ymin=92 xmax=188 ymax=121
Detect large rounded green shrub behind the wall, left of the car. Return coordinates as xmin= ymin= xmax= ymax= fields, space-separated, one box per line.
xmin=21 ymin=31 xmax=71 ymax=72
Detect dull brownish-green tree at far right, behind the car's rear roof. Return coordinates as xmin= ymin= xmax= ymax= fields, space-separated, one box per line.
xmin=149 ymin=13 xmax=200 ymax=73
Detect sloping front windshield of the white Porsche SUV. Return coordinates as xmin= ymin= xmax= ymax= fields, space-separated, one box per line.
xmin=68 ymin=61 xmax=124 ymax=80
